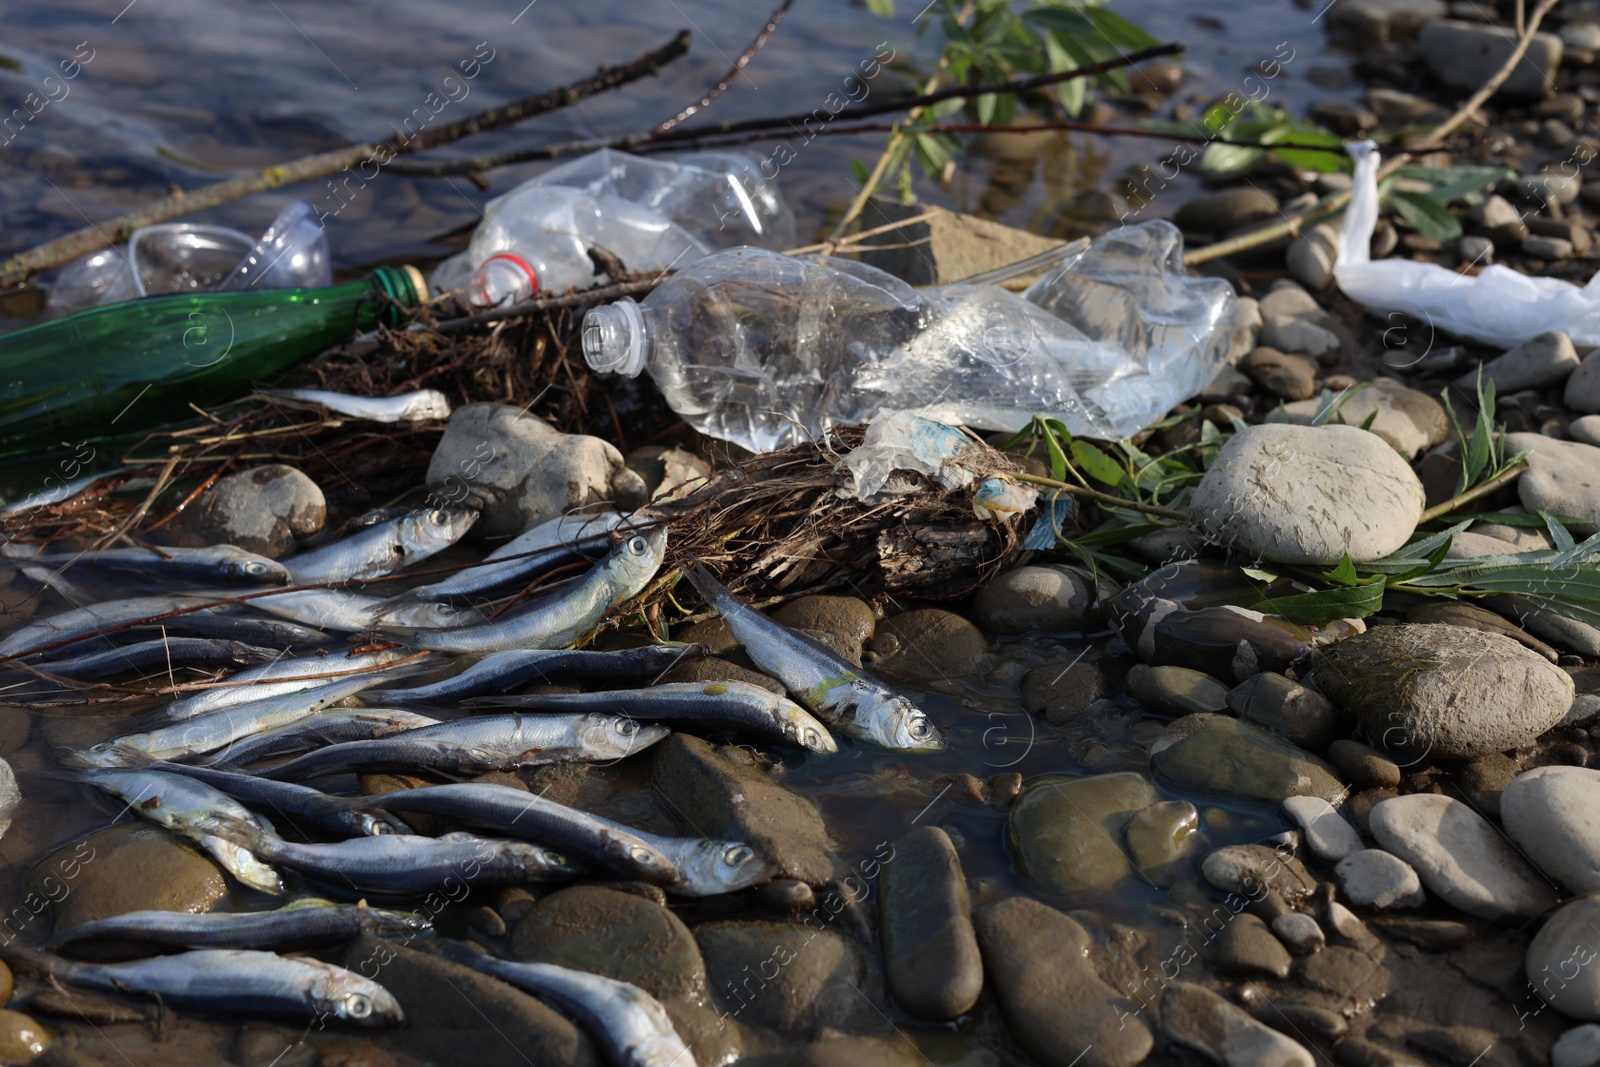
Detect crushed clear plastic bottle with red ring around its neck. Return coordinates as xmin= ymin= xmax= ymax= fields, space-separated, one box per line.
xmin=432 ymin=149 xmax=794 ymax=307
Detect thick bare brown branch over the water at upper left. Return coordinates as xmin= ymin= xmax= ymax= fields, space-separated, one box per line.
xmin=0 ymin=30 xmax=690 ymax=288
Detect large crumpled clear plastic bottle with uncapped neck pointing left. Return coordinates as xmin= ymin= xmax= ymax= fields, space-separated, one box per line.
xmin=582 ymin=221 xmax=1237 ymax=451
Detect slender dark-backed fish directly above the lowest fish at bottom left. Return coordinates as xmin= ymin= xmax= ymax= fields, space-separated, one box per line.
xmin=53 ymin=897 xmax=434 ymax=950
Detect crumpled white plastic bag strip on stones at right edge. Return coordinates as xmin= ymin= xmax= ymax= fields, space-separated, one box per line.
xmin=1333 ymin=141 xmax=1600 ymax=349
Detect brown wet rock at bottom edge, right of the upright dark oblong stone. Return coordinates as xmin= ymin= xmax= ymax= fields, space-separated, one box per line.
xmin=973 ymin=897 xmax=1155 ymax=1067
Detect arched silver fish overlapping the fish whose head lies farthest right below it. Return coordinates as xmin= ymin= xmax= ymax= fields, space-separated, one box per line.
xmin=362 ymin=782 xmax=678 ymax=885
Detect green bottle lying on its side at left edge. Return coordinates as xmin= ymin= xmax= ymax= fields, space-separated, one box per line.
xmin=0 ymin=267 xmax=427 ymax=456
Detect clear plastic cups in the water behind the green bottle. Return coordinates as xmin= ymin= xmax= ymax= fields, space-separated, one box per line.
xmin=46 ymin=200 xmax=333 ymax=315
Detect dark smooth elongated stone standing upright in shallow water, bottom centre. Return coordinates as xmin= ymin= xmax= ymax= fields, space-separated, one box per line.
xmin=878 ymin=825 xmax=984 ymax=1022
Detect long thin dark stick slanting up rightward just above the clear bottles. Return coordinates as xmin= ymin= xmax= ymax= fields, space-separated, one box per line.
xmin=386 ymin=43 xmax=1184 ymax=178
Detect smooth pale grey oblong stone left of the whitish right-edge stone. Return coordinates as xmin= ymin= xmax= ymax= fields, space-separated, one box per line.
xmin=1368 ymin=793 xmax=1555 ymax=921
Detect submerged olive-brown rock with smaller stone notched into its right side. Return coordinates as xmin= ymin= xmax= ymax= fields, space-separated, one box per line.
xmin=1006 ymin=771 xmax=1160 ymax=894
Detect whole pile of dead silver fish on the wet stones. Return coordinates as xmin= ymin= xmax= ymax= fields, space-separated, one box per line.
xmin=0 ymin=507 xmax=944 ymax=1065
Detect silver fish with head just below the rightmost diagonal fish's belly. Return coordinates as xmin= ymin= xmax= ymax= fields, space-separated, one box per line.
xmin=467 ymin=681 xmax=838 ymax=752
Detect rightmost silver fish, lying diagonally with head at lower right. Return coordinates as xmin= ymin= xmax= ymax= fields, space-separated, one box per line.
xmin=683 ymin=563 xmax=944 ymax=752
